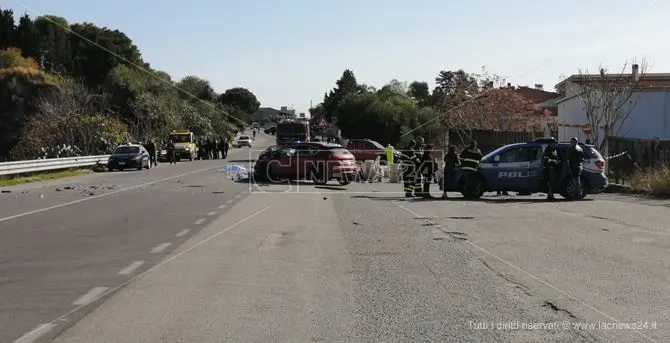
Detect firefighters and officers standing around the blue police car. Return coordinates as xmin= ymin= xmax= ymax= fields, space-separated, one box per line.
xmin=400 ymin=137 xmax=584 ymax=200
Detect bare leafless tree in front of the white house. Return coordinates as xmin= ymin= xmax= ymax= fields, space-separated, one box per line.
xmin=574 ymin=61 xmax=646 ymax=151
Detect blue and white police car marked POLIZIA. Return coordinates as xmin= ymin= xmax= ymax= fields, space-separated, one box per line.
xmin=439 ymin=138 xmax=607 ymax=200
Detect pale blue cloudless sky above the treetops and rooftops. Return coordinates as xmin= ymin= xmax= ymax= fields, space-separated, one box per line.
xmin=2 ymin=0 xmax=670 ymax=112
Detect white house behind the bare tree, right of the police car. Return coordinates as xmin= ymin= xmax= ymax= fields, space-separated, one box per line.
xmin=556 ymin=65 xmax=670 ymax=144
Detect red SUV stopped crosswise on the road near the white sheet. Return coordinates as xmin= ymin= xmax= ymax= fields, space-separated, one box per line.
xmin=254 ymin=143 xmax=358 ymax=185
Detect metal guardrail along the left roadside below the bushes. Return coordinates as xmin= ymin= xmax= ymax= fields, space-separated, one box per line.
xmin=0 ymin=155 xmax=110 ymax=176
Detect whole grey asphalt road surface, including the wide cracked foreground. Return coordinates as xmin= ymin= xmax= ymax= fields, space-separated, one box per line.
xmin=0 ymin=136 xmax=670 ymax=343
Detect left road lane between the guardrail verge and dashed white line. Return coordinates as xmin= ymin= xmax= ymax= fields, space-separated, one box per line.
xmin=0 ymin=130 xmax=271 ymax=342
